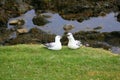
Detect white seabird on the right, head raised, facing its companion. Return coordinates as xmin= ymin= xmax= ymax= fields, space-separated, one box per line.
xmin=67 ymin=33 xmax=82 ymax=49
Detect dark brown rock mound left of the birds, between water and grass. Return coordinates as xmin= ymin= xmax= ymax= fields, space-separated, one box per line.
xmin=9 ymin=28 xmax=55 ymax=45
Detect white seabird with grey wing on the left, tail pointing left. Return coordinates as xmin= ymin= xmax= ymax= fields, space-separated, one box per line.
xmin=45 ymin=35 xmax=62 ymax=50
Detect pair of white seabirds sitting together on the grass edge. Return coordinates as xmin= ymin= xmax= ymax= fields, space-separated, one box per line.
xmin=45 ymin=33 xmax=82 ymax=50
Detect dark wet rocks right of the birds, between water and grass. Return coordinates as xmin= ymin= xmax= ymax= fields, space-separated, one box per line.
xmin=73 ymin=31 xmax=120 ymax=50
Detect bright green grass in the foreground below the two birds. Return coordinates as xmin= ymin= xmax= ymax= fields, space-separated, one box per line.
xmin=0 ymin=45 xmax=120 ymax=80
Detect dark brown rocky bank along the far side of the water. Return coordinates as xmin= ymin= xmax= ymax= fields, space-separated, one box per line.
xmin=0 ymin=0 xmax=120 ymax=27
